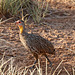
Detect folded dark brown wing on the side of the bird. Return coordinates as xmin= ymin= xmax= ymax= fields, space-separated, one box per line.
xmin=29 ymin=35 xmax=54 ymax=53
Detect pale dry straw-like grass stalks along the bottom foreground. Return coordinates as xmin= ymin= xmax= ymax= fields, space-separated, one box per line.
xmin=0 ymin=56 xmax=75 ymax=75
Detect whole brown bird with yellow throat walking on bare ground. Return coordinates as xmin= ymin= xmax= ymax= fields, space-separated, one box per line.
xmin=16 ymin=20 xmax=55 ymax=68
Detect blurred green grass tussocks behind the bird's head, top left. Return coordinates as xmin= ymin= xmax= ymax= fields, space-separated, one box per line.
xmin=0 ymin=0 xmax=48 ymax=23
